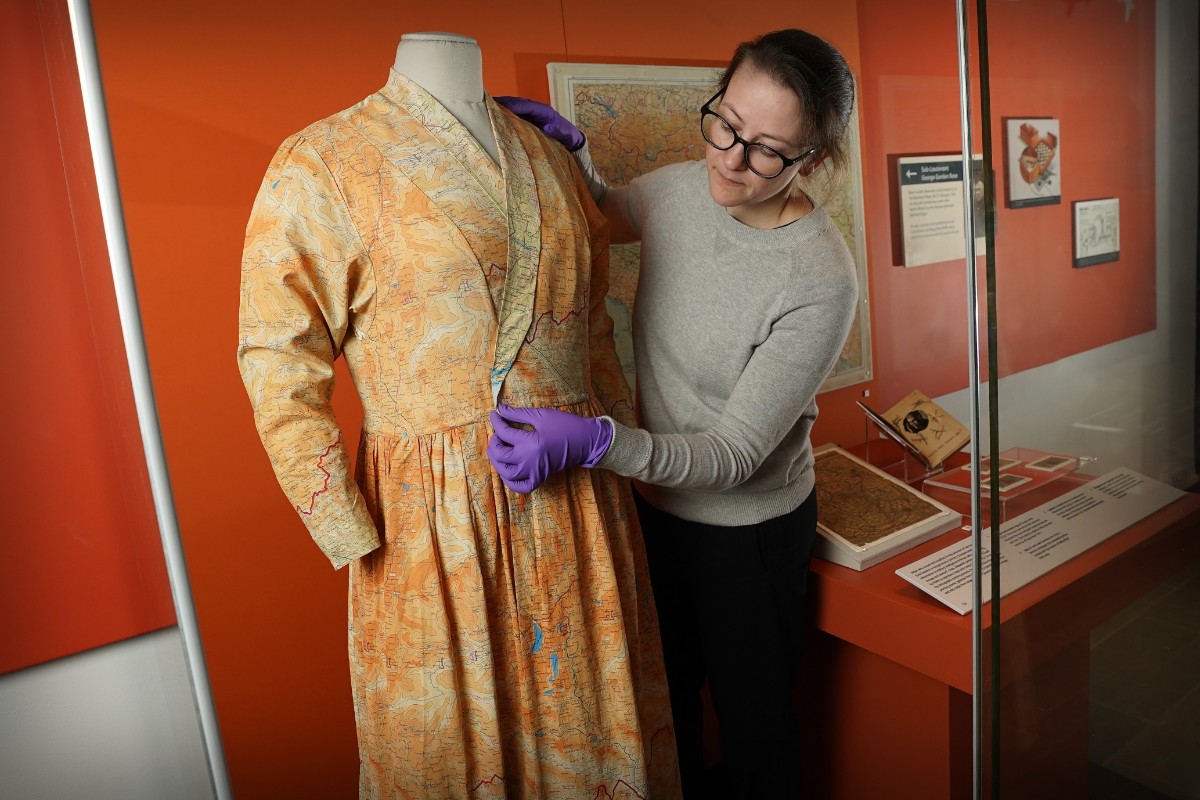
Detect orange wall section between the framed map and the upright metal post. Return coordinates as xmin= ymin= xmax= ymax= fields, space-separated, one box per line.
xmin=858 ymin=0 xmax=978 ymax=400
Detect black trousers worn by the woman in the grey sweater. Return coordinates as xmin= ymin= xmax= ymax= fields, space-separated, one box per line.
xmin=635 ymin=491 xmax=817 ymax=800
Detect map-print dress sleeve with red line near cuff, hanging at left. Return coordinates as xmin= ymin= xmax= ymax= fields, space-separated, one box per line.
xmin=238 ymin=137 xmax=379 ymax=569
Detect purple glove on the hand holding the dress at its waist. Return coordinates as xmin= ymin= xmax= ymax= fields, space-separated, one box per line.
xmin=487 ymin=405 xmax=612 ymax=494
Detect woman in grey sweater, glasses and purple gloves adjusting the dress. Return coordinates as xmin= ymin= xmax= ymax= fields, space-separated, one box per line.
xmin=488 ymin=30 xmax=857 ymax=798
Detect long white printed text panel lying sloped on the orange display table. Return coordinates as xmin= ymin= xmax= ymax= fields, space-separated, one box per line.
xmin=896 ymin=469 xmax=1183 ymax=614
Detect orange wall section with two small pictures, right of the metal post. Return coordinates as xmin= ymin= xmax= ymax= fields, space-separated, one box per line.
xmin=989 ymin=1 xmax=1156 ymax=374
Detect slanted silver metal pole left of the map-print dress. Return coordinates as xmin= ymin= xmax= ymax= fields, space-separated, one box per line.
xmin=67 ymin=0 xmax=233 ymax=800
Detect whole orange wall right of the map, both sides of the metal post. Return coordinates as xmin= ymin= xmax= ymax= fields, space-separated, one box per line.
xmin=858 ymin=0 xmax=1154 ymax=400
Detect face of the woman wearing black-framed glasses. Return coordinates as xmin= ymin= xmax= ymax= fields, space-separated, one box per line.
xmin=704 ymin=66 xmax=808 ymax=222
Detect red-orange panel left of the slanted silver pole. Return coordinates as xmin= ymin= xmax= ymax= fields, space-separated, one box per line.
xmin=0 ymin=1 xmax=175 ymax=673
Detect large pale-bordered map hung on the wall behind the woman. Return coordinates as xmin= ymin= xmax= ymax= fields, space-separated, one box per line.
xmin=546 ymin=62 xmax=871 ymax=391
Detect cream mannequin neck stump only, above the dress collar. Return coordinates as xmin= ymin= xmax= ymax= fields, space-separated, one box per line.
xmin=395 ymin=32 xmax=484 ymax=108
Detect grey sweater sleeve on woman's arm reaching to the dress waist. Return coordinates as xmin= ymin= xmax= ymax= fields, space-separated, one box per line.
xmin=596 ymin=260 xmax=858 ymax=492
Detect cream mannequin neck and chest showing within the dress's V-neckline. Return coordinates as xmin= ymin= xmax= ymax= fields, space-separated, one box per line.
xmin=394 ymin=31 xmax=499 ymax=163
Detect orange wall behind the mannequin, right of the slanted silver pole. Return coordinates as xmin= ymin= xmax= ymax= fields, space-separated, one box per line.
xmin=92 ymin=0 xmax=562 ymax=799
